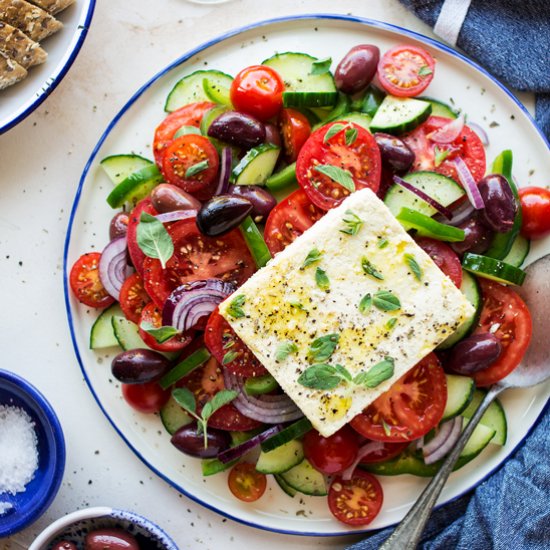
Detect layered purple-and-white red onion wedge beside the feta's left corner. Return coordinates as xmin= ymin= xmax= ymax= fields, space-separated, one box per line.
xmin=162 ymin=279 xmax=235 ymax=332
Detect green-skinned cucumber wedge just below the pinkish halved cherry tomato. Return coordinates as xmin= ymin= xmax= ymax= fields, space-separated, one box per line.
xmin=370 ymin=96 xmax=432 ymax=135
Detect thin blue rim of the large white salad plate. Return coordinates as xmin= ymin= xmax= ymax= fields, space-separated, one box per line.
xmin=63 ymin=13 xmax=550 ymax=537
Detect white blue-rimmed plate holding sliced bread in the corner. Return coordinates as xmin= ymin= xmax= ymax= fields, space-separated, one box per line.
xmin=0 ymin=0 xmax=95 ymax=134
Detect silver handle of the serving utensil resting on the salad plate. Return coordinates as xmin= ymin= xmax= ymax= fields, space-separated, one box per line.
xmin=379 ymin=385 xmax=503 ymax=550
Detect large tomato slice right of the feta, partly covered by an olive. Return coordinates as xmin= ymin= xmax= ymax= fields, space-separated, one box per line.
xmin=472 ymin=278 xmax=533 ymax=386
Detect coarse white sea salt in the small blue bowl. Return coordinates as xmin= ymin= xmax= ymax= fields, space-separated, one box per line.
xmin=0 ymin=405 xmax=38 ymax=500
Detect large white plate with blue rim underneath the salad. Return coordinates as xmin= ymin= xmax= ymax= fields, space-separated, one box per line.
xmin=64 ymin=14 xmax=550 ymax=536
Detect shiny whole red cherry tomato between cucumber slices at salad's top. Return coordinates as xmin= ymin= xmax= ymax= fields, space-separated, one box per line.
xmin=230 ymin=65 xmax=285 ymax=120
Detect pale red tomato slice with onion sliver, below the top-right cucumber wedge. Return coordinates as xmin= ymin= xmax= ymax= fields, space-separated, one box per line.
xmin=402 ymin=116 xmax=486 ymax=181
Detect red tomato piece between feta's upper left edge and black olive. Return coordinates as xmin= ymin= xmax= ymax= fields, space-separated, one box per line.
xmin=264 ymin=189 xmax=325 ymax=256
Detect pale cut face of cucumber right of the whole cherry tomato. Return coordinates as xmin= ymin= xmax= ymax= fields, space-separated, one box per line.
xmin=262 ymin=52 xmax=336 ymax=93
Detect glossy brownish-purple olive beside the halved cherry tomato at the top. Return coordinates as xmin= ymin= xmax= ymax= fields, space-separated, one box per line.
xmin=334 ymin=44 xmax=380 ymax=94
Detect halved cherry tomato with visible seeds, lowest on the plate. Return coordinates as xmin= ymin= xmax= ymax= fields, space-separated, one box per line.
xmin=328 ymin=469 xmax=384 ymax=526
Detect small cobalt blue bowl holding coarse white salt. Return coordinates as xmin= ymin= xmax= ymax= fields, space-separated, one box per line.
xmin=0 ymin=369 xmax=65 ymax=539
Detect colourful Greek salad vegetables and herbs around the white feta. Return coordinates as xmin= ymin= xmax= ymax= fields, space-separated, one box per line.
xmin=69 ymin=44 xmax=550 ymax=526
